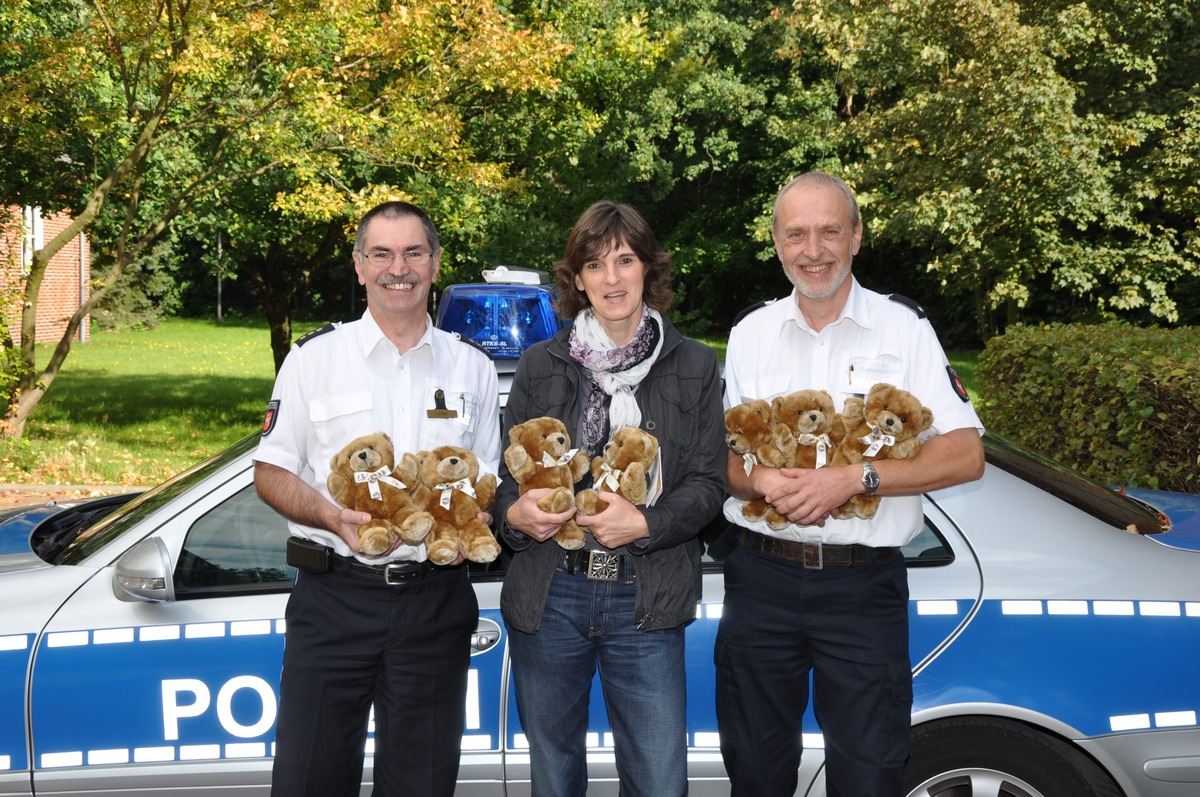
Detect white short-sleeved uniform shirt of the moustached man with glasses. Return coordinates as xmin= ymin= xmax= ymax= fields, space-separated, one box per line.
xmin=254 ymin=311 xmax=500 ymax=564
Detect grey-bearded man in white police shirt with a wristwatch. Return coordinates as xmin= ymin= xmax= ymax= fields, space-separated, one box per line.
xmin=714 ymin=173 xmax=983 ymax=797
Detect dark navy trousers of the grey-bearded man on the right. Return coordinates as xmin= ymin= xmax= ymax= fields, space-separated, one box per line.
xmin=714 ymin=547 xmax=912 ymax=797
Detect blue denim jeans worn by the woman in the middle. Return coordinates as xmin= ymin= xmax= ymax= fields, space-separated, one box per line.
xmin=509 ymin=570 xmax=688 ymax=797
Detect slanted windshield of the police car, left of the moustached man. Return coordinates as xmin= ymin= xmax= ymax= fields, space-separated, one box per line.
xmin=49 ymin=432 xmax=259 ymax=564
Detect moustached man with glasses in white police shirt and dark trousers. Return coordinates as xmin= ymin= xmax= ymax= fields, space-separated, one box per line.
xmin=254 ymin=202 xmax=500 ymax=797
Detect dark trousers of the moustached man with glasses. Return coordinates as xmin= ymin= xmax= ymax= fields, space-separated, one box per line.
xmin=271 ymin=567 xmax=479 ymax=797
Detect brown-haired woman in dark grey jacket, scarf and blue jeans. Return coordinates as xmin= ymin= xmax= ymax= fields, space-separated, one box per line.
xmin=494 ymin=202 xmax=726 ymax=797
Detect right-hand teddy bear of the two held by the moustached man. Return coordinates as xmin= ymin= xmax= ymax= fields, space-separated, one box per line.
xmin=414 ymin=445 xmax=500 ymax=564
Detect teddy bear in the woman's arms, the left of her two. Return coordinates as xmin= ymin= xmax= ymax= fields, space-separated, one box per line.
xmin=504 ymin=417 xmax=588 ymax=551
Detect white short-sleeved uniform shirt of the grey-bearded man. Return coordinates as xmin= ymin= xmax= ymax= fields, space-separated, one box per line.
xmin=725 ymin=277 xmax=983 ymax=547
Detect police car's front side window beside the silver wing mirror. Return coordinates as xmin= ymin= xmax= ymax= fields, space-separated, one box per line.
xmin=175 ymin=484 xmax=295 ymax=599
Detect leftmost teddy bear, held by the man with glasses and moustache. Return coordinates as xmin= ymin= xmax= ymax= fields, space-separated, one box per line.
xmin=325 ymin=432 xmax=433 ymax=556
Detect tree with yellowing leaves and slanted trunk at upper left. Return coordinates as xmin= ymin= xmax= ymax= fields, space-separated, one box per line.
xmin=0 ymin=0 xmax=559 ymax=436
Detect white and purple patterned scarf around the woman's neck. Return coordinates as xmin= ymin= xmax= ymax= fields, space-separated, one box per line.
xmin=570 ymin=305 xmax=662 ymax=454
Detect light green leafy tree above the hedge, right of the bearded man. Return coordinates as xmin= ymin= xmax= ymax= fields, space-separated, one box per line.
xmin=791 ymin=0 xmax=1189 ymax=340
